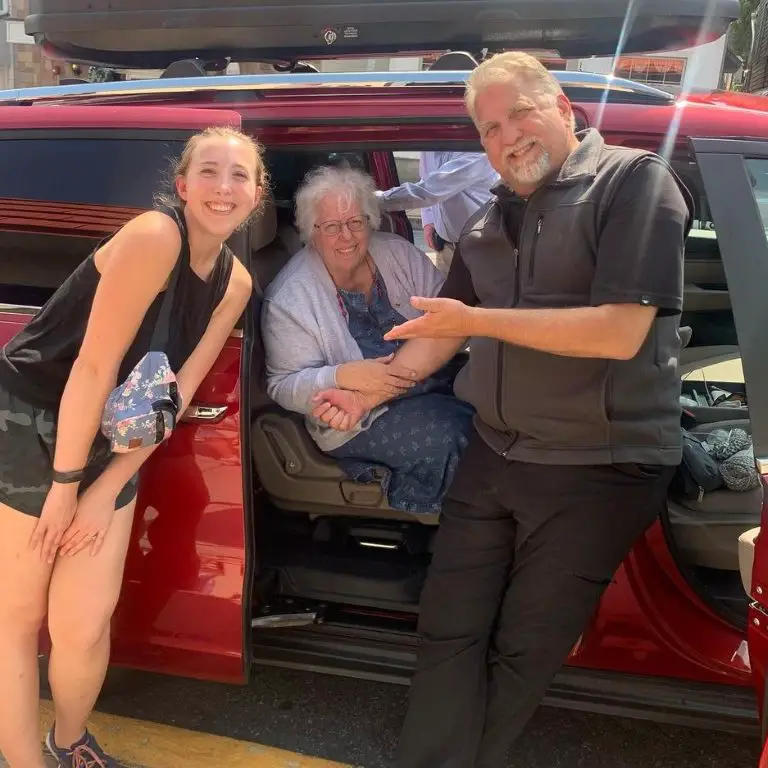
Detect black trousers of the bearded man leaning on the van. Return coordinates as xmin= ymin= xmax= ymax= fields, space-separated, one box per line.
xmin=398 ymin=434 xmax=674 ymax=768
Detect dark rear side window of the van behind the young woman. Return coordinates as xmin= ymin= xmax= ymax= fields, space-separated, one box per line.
xmin=0 ymin=129 xmax=185 ymax=307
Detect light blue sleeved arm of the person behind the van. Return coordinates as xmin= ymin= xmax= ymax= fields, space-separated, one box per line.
xmin=377 ymin=152 xmax=498 ymax=211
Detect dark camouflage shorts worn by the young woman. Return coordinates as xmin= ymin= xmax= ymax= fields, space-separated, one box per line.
xmin=0 ymin=387 xmax=138 ymax=517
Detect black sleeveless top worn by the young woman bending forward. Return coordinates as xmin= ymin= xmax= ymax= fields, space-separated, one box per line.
xmin=0 ymin=208 xmax=234 ymax=410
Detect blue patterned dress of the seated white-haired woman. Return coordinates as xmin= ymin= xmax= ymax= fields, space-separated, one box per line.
xmin=328 ymin=271 xmax=474 ymax=513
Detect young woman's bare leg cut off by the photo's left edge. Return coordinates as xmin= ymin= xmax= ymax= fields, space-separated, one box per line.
xmin=0 ymin=504 xmax=51 ymax=768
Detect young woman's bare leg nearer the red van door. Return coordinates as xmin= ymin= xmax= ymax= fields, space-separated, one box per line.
xmin=48 ymin=501 xmax=136 ymax=748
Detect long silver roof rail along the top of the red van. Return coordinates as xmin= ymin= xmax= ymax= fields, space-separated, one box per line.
xmin=0 ymin=70 xmax=675 ymax=105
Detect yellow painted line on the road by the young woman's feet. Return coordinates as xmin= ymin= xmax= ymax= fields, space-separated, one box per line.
xmin=37 ymin=701 xmax=350 ymax=768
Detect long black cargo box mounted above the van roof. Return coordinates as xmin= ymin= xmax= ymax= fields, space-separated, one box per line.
xmin=25 ymin=0 xmax=739 ymax=69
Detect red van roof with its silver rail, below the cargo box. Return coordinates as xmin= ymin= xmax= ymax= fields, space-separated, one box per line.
xmin=0 ymin=70 xmax=768 ymax=143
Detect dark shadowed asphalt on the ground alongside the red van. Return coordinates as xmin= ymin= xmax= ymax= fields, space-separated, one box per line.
xmin=75 ymin=667 xmax=759 ymax=768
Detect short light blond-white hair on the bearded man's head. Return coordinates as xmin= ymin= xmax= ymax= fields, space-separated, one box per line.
xmin=464 ymin=51 xmax=576 ymax=129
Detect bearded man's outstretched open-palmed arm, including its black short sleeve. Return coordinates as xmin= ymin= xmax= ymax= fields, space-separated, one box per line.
xmin=387 ymin=157 xmax=691 ymax=359
